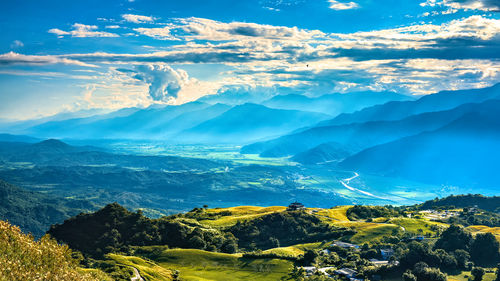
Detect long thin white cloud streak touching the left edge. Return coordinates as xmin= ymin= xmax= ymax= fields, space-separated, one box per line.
xmin=0 ymin=52 xmax=95 ymax=67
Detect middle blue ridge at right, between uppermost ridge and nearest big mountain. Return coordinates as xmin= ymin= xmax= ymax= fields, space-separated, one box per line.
xmin=241 ymin=86 xmax=500 ymax=162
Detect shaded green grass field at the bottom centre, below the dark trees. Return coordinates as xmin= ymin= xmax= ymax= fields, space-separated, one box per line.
xmin=136 ymin=247 xmax=293 ymax=281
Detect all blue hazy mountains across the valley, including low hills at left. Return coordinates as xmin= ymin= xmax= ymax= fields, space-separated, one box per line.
xmin=0 ymin=84 xmax=500 ymax=186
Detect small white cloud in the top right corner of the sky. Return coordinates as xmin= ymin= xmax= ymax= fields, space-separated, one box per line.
xmin=420 ymin=0 xmax=500 ymax=12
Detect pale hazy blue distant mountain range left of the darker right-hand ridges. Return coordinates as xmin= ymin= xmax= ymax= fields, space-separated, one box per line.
xmin=4 ymin=89 xmax=413 ymax=144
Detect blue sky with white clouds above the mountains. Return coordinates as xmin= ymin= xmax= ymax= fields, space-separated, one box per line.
xmin=0 ymin=0 xmax=500 ymax=120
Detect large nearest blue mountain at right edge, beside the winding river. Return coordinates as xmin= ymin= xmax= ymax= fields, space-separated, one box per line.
xmin=340 ymin=108 xmax=500 ymax=190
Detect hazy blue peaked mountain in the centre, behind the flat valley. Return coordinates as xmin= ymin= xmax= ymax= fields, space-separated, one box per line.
xmin=176 ymin=103 xmax=330 ymax=143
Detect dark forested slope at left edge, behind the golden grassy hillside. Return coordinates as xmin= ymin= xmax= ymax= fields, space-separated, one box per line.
xmin=0 ymin=179 xmax=96 ymax=237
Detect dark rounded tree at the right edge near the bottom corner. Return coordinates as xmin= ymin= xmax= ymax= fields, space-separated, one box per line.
xmin=470 ymin=233 xmax=500 ymax=265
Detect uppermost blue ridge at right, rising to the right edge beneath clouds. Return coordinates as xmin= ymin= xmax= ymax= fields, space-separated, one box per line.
xmin=321 ymin=83 xmax=500 ymax=126
